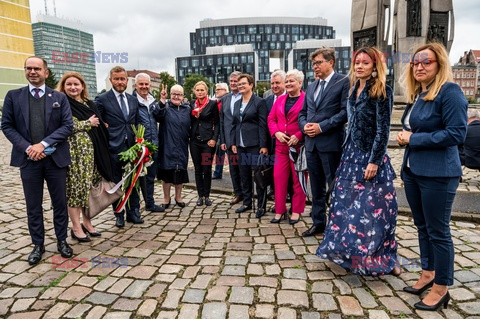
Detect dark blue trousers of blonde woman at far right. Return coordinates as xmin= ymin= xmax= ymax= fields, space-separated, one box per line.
xmin=402 ymin=167 xmax=459 ymax=286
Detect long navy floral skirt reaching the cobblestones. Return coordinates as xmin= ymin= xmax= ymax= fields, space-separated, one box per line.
xmin=317 ymin=139 xmax=398 ymax=276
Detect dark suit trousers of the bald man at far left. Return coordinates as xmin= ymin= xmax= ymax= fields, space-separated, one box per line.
xmin=20 ymin=156 xmax=68 ymax=245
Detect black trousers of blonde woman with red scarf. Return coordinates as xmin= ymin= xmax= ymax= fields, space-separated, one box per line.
xmin=190 ymin=138 xmax=215 ymax=197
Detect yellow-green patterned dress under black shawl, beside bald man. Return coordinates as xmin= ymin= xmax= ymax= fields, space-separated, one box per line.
xmin=67 ymin=109 xmax=101 ymax=208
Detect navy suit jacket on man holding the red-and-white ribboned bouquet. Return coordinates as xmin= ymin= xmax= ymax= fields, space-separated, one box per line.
xmin=95 ymin=90 xmax=139 ymax=154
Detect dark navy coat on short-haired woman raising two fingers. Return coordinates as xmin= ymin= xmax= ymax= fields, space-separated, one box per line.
xmin=153 ymin=101 xmax=191 ymax=170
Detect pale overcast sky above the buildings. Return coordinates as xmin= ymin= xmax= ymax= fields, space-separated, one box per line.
xmin=30 ymin=0 xmax=480 ymax=91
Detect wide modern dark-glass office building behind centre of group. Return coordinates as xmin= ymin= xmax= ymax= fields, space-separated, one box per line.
xmin=176 ymin=17 xmax=335 ymax=83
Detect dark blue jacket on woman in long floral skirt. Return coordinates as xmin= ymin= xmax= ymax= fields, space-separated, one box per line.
xmin=344 ymin=83 xmax=393 ymax=165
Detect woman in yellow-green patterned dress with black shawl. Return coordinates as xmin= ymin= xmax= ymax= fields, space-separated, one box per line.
xmin=57 ymin=72 xmax=112 ymax=242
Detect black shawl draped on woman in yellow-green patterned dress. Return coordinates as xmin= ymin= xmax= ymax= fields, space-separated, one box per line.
xmin=67 ymin=96 xmax=113 ymax=181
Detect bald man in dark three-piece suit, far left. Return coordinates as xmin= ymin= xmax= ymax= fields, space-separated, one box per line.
xmin=2 ymin=56 xmax=73 ymax=265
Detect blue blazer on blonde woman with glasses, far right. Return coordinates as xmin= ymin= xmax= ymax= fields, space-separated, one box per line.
xmin=402 ymin=82 xmax=468 ymax=177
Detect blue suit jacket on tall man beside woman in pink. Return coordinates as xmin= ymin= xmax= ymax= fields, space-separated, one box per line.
xmin=298 ymin=73 xmax=350 ymax=152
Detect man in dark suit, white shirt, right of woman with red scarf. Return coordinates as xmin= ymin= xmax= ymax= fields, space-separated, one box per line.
xmin=220 ymin=71 xmax=243 ymax=205
